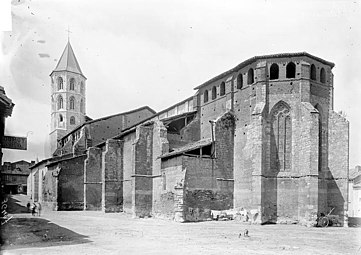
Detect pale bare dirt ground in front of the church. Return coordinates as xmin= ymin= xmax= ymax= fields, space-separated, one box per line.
xmin=1 ymin=195 xmax=361 ymax=255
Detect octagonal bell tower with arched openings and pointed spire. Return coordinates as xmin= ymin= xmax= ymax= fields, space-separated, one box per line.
xmin=49 ymin=40 xmax=86 ymax=156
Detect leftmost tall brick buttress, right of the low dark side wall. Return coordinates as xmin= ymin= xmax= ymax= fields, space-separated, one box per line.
xmin=83 ymin=147 xmax=102 ymax=210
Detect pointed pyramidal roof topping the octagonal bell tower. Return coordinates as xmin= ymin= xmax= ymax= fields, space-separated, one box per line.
xmin=50 ymin=41 xmax=85 ymax=78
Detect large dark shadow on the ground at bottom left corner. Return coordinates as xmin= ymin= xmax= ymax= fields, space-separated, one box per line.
xmin=0 ymin=217 xmax=91 ymax=250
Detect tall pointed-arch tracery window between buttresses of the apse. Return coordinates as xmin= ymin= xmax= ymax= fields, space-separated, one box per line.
xmin=270 ymin=101 xmax=292 ymax=172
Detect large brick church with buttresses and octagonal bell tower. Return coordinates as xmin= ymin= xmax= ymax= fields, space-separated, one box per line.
xmin=29 ymin=40 xmax=349 ymax=224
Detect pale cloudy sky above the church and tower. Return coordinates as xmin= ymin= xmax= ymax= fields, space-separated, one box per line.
xmin=0 ymin=0 xmax=361 ymax=168
